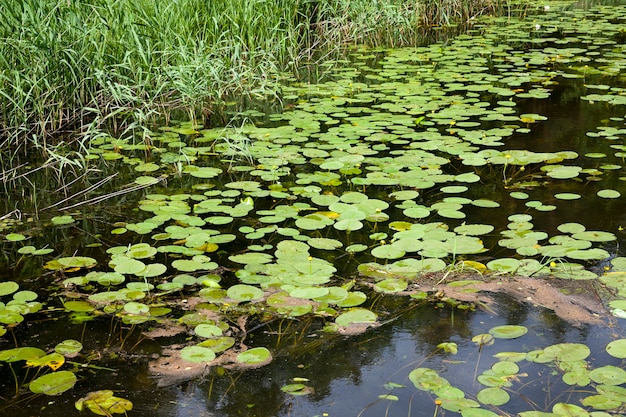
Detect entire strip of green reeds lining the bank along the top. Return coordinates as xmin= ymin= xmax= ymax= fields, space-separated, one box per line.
xmin=0 ymin=0 xmax=502 ymax=162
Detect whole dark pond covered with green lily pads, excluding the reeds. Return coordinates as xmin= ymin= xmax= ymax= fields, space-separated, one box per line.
xmin=0 ymin=3 xmax=626 ymax=417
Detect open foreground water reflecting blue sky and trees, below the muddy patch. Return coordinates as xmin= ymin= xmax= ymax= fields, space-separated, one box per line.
xmin=144 ymin=297 xmax=624 ymax=417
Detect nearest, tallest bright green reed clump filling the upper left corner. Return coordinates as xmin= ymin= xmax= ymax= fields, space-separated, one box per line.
xmin=0 ymin=0 xmax=308 ymax=149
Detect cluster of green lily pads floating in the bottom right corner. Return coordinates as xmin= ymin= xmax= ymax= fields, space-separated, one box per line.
xmin=372 ymin=325 xmax=626 ymax=417
